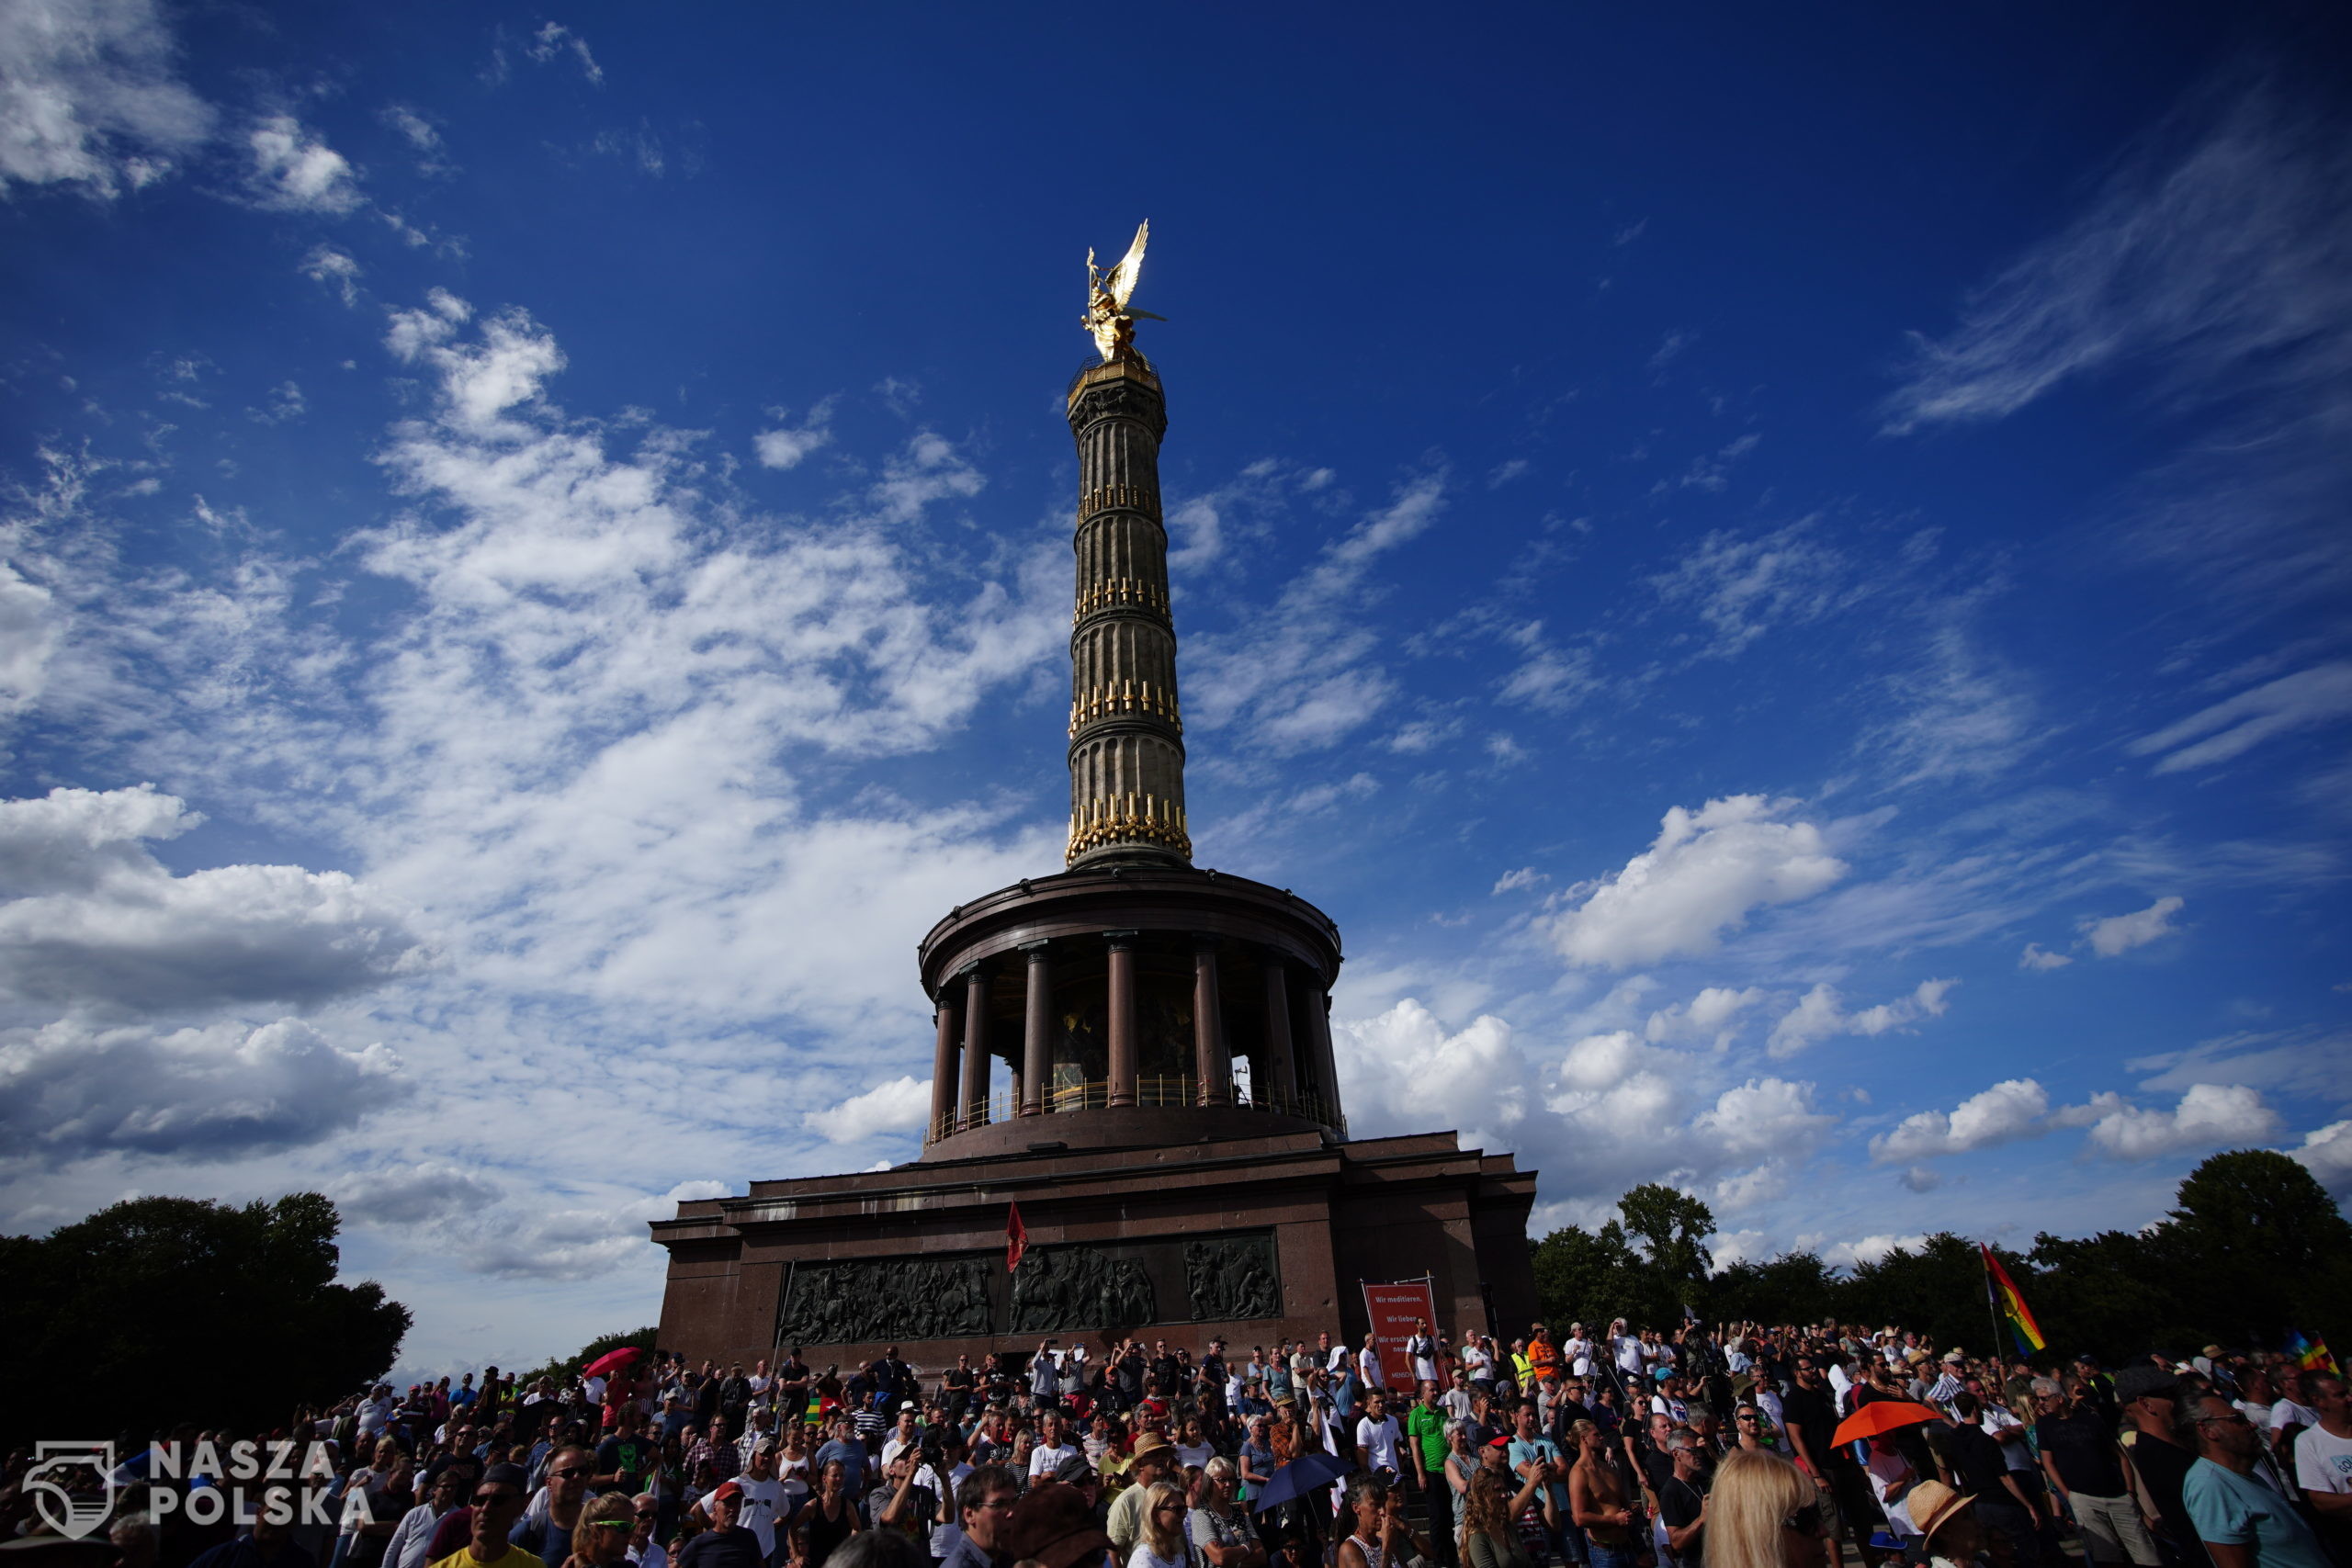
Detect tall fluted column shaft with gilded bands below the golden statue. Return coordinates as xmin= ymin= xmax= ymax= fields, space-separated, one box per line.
xmin=1066 ymin=357 xmax=1193 ymax=865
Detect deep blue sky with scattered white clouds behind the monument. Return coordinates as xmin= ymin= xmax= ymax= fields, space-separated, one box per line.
xmin=0 ymin=0 xmax=2352 ymax=1371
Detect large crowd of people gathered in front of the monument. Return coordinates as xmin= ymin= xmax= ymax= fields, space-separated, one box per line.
xmin=0 ymin=1321 xmax=2352 ymax=1568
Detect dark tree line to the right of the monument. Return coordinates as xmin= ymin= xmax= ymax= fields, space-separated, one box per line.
xmin=1533 ymin=1149 xmax=2352 ymax=1366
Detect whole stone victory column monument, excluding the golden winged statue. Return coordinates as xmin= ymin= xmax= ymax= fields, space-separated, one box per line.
xmin=651 ymin=350 xmax=1533 ymax=1368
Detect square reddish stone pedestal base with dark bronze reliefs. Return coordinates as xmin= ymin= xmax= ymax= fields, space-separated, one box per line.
xmin=651 ymin=1119 xmax=1536 ymax=1375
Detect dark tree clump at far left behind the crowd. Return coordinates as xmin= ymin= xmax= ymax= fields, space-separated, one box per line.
xmin=0 ymin=1192 xmax=409 ymax=1443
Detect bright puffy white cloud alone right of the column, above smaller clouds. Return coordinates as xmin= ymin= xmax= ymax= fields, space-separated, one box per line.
xmin=1550 ymin=795 xmax=1847 ymax=968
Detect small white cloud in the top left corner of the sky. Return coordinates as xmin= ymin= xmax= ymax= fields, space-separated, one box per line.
xmin=0 ymin=0 xmax=211 ymax=197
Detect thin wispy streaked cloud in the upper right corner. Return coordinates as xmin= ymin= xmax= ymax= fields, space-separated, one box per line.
xmin=1886 ymin=80 xmax=2352 ymax=611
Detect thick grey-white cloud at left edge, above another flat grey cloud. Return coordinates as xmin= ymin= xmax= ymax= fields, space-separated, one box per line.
xmin=0 ymin=785 xmax=419 ymax=1010
